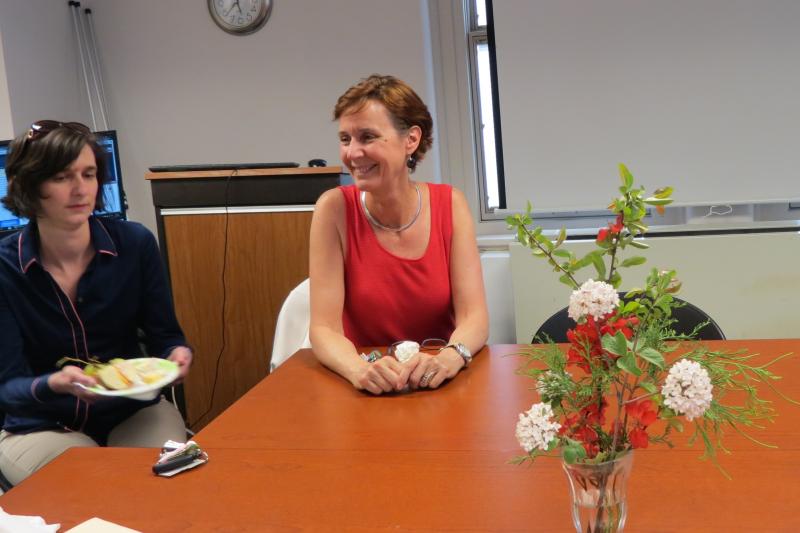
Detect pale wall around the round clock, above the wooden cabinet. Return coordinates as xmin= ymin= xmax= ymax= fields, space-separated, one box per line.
xmin=93 ymin=0 xmax=435 ymax=227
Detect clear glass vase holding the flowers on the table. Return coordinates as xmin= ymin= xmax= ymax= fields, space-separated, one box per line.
xmin=563 ymin=451 xmax=633 ymax=533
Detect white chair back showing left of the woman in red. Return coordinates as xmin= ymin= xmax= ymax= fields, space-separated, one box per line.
xmin=270 ymin=278 xmax=311 ymax=372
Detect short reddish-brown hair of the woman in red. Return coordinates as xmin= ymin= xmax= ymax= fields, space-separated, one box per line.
xmin=333 ymin=74 xmax=433 ymax=172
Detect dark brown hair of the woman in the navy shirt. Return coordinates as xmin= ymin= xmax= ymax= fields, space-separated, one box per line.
xmin=2 ymin=121 xmax=107 ymax=219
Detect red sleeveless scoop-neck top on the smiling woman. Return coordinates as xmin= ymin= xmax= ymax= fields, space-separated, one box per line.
xmin=339 ymin=183 xmax=455 ymax=346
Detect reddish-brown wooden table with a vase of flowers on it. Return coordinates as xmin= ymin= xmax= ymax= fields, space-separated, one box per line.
xmin=0 ymin=340 xmax=800 ymax=532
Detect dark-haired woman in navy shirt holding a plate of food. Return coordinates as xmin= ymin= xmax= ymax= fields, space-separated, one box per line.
xmin=0 ymin=120 xmax=192 ymax=483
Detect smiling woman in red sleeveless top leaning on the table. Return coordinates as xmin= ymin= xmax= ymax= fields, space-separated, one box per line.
xmin=310 ymin=75 xmax=488 ymax=394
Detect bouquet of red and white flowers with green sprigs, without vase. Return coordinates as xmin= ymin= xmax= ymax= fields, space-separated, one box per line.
xmin=506 ymin=165 xmax=796 ymax=473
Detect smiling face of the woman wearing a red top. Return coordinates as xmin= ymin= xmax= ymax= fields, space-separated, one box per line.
xmin=339 ymin=100 xmax=420 ymax=190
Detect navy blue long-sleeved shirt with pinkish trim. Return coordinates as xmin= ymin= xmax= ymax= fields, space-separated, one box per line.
xmin=0 ymin=217 xmax=186 ymax=444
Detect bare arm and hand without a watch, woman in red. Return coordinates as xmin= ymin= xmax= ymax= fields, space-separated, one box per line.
xmin=309 ymin=189 xmax=408 ymax=394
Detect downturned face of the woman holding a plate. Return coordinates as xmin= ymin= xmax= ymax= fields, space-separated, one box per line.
xmin=37 ymin=145 xmax=99 ymax=227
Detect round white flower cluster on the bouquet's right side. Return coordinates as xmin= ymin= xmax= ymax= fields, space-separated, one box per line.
xmin=661 ymin=359 xmax=713 ymax=421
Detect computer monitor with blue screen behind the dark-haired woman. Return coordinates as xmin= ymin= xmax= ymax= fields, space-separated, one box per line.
xmin=0 ymin=130 xmax=127 ymax=234
